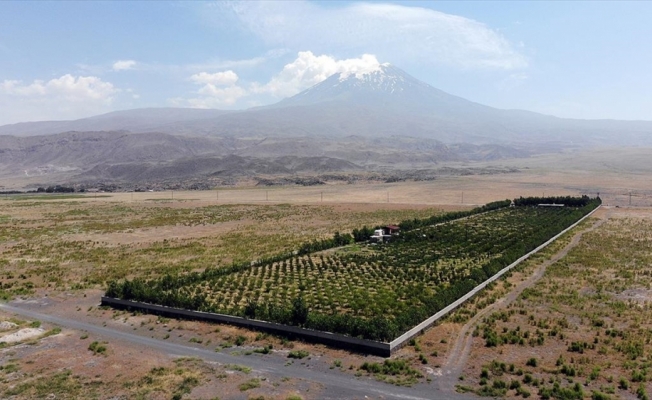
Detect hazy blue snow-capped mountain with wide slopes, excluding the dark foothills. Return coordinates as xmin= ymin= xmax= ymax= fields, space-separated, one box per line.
xmin=0 ymin=64 xmax=652 ymax=147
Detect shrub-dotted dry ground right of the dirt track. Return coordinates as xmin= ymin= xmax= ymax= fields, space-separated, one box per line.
xmin=460 ymin=211 xmax=652 ymax=399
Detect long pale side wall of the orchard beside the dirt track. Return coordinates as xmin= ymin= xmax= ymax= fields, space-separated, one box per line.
xmin=389 ymin=205 xmax=602 ymax=353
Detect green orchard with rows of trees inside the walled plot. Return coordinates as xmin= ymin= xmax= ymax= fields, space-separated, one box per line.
xmin=107 ymin=200 xmax=599 ymax=341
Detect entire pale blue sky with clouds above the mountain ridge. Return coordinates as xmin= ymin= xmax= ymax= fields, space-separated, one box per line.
xmin=0 ymin=0 xmax=652 ymax=125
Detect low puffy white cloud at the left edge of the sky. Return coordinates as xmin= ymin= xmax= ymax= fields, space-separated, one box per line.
xmin=0 ymin=74 xmax=120 ymax=124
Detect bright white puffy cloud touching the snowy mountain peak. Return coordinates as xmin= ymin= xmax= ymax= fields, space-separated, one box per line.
xmin=252 ymin=51 xmax=380 ymax=97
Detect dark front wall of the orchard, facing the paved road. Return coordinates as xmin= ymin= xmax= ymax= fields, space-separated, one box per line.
xmin=102 ymin=296 xmax=391 ymax=357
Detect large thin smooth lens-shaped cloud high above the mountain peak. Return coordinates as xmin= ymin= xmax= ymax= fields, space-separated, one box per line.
xmin=222 ymin=1 xmax=528 ymax=70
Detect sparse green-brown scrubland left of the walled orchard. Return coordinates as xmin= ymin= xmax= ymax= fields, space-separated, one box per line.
xmin=0 ymin=202 xmax=440 ymax=300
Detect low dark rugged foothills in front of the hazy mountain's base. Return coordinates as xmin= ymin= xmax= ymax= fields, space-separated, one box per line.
xmin=0 ymin=131 xmax=473 ymax=182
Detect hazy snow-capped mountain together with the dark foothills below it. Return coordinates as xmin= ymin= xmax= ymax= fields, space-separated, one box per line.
xmin=0 ymin=64 xmax=652 ymax=186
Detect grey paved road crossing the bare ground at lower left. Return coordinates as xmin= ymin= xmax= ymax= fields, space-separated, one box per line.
xmin=0 ymin=304 xmax=476 ymax=400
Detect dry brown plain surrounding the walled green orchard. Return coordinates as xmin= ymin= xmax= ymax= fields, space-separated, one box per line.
xmin=0 ymin=148 xmax=652 ymax=399
